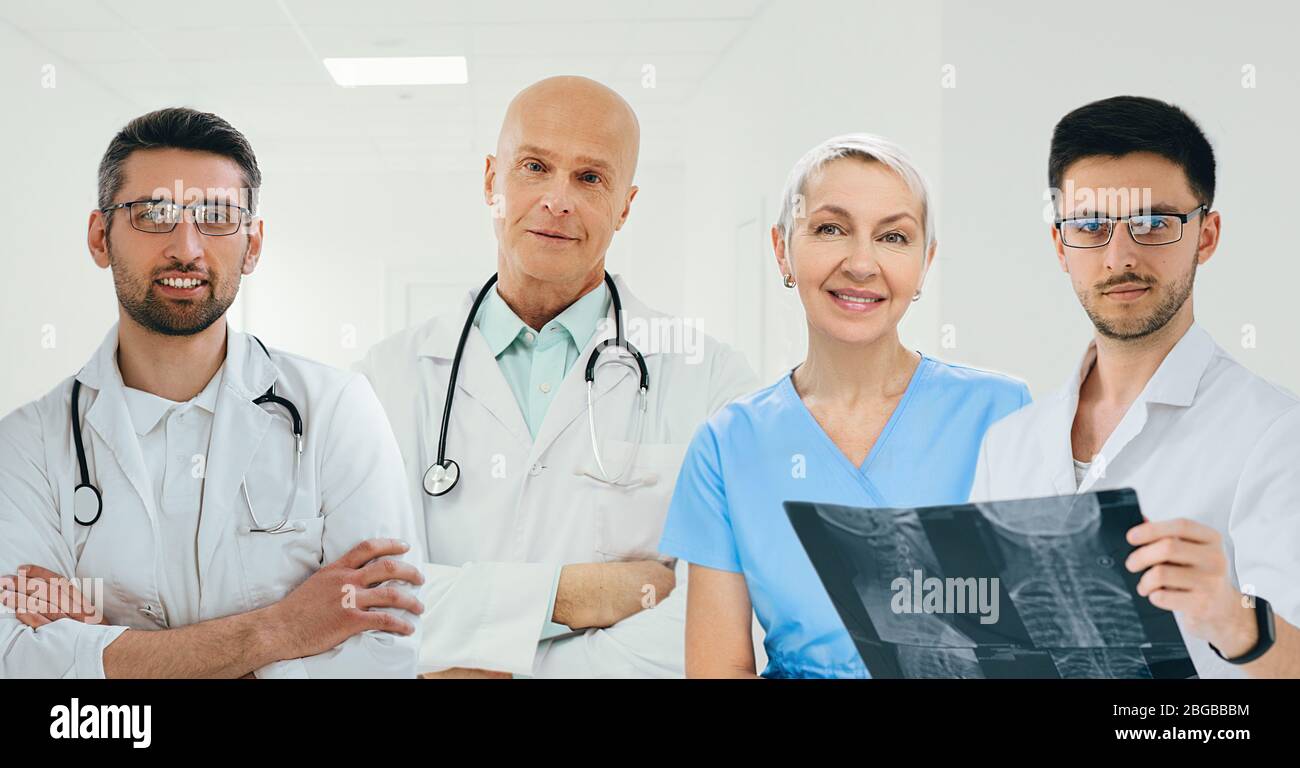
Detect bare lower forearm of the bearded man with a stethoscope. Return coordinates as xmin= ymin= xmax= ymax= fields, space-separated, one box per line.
xmin=104 ymin=608 xmax=281 ymax=677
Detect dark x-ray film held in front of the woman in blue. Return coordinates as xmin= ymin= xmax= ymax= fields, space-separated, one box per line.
xmin=785 ymin=489 xmax=1196 ymax=678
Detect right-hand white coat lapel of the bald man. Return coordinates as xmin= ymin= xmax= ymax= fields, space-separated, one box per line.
xmin=529 ymin=275 xmax=654 ymax=464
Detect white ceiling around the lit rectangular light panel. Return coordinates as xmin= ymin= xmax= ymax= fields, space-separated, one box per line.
xmin=0 ymin=0 xmax=770 ymax=173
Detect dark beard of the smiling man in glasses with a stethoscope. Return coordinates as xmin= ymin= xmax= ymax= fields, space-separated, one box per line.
xmin=108 ymin=241 xmax=241 ymax=337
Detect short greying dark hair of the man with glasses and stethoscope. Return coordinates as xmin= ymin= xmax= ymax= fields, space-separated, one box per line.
xmin=99 ymin=107 xmax=261 ymax=211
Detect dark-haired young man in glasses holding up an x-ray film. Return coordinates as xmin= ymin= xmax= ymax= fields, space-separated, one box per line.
xmin=971 ymin=96 xmax=1300 ymax=677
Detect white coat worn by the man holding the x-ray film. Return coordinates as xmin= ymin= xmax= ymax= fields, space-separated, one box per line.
xmin=971 ymin=324 xmax=1300 ymax=677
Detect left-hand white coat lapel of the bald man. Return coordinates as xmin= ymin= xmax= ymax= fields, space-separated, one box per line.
xmin=420 ymin=292 xmax=530 ymax=442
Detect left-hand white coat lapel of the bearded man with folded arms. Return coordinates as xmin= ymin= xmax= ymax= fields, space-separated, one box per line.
xmin=77 ymin=324 xmax=157 ymax=525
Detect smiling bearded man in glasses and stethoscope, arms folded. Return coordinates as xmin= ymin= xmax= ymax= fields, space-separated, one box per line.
xmin=0 ymin=109 xmax=423 ymax=678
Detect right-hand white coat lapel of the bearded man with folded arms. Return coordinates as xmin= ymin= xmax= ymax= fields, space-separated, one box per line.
xmin=198 ymin=330 xmax=271 ymax=585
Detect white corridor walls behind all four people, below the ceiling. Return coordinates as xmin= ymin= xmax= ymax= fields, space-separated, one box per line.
xmin=10 ymin=0 xmax=1300 ymax=413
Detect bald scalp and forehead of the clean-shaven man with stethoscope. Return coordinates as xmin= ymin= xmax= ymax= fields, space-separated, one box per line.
xmin=497 ymin=75 xmax=641 ymax=186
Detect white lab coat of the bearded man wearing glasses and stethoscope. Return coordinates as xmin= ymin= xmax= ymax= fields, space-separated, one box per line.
xmin=0 ymin=326 xmax=423 ymax=677
